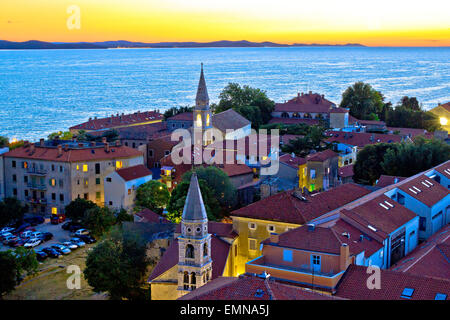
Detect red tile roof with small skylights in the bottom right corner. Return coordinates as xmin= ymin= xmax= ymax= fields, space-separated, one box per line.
xmin=336 ymin=264 xmax=450 ymax=300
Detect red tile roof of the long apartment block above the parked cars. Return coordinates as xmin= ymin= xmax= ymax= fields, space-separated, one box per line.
xmin=3 ymin=144 xmax=142 ymax=162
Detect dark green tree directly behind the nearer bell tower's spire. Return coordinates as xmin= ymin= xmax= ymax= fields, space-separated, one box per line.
xmin=183 ymin=166 xmax=237 ymax=210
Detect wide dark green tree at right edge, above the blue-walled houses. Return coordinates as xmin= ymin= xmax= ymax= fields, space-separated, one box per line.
xmin=381 ymin=137 xmax=450 ymax=177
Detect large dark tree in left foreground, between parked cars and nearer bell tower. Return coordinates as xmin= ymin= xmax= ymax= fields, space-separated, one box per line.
xmin=84 ymin=229 xmax=152 ymax=300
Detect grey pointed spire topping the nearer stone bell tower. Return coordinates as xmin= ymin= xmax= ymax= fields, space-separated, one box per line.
xmin=181 ymin=172 xmax=208 ymax=221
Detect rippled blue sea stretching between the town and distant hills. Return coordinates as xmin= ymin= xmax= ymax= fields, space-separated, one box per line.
xmin=0 ymin=47 xmax=450 ymax=139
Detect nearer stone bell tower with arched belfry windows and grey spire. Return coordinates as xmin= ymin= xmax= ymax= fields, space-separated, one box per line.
xmin=178 ymin=172 xmax=212 ymax=297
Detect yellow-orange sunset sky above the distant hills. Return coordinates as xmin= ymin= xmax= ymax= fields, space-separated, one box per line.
xmin=0 ymin=0 xmax=450 ymax=46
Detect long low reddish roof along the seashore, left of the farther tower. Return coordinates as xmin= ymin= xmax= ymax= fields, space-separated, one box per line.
xmin=70 ymin=111 xmax=163 ymax=130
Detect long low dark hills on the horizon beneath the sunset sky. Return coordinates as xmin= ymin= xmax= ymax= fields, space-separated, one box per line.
xmin=0 ymin=40 xmax=364 ymax=50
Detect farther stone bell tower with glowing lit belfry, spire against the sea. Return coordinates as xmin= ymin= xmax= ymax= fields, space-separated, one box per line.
xmin=192 ymin=63 xmax=212 ymax=145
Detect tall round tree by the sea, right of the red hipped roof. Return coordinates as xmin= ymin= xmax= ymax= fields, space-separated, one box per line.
xmin=340 ymin=82 xmax=384 ymax=120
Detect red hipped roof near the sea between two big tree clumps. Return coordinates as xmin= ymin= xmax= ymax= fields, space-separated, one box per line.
xmin=274 ymin=93 xmax=334 ymax=113
